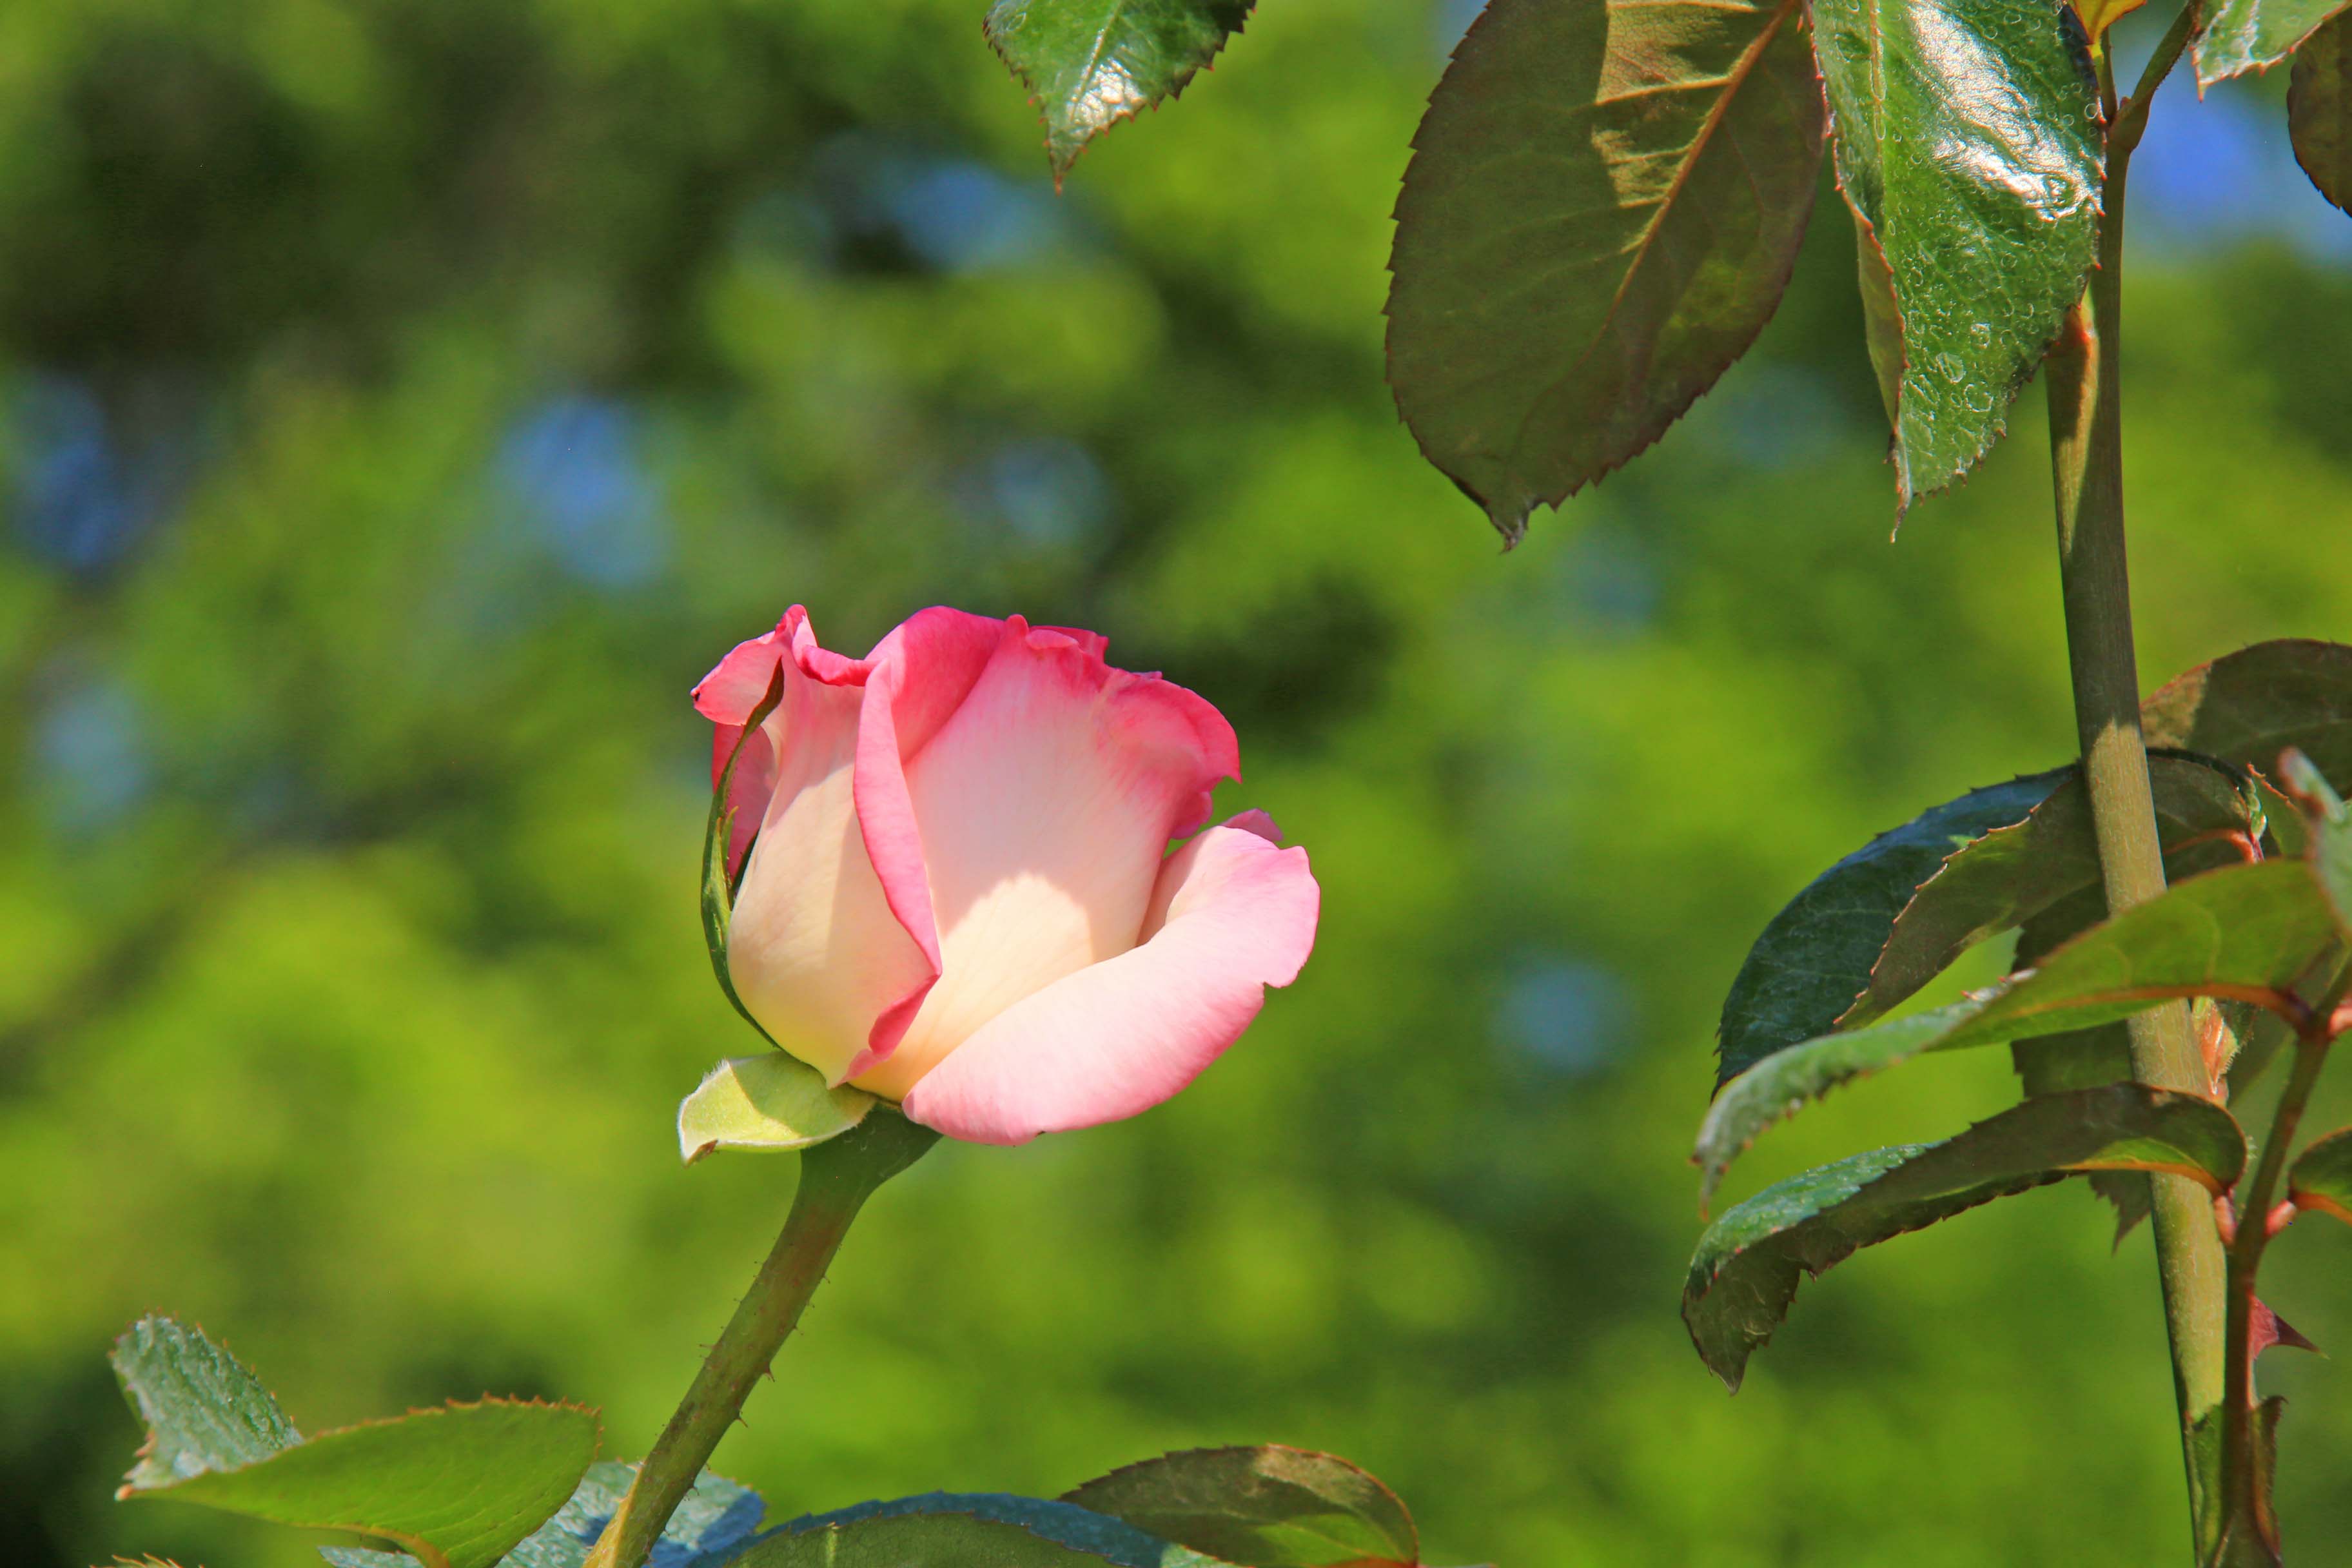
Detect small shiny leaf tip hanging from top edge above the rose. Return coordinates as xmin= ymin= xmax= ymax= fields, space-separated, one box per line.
xmin=983 ymin=0 xmax=1249 ymax=183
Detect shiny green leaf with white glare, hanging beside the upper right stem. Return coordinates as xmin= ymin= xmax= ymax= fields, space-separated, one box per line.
xmin=1814 ymin=0 xmax=2101 ymax=508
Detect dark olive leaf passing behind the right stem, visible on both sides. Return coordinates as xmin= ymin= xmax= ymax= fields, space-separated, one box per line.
xmin=1837 ymin=757 xmax=2265 ymax=1027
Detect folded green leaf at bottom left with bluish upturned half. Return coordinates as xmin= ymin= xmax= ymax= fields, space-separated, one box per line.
xmin=113 ymin=1319 xmax=600 ymax=1568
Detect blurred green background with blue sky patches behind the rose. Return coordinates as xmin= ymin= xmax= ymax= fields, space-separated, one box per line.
xmin=0 ymin=0 xmax=2352 ymax=1568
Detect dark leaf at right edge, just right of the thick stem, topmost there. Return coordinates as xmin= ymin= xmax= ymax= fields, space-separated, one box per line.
xmin=2141 ymin=637 xmax=2352 ymax=778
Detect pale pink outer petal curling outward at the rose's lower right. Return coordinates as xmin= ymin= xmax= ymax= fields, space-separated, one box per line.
xmin=905 ymin=827 xmax=1320 ymax=1142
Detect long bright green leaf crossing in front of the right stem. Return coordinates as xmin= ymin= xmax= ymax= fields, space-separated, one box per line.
xmin=1694 ymin=861 xmax=2338 ymax=1194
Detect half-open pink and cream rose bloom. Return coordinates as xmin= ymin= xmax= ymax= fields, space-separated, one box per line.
xmin=694 ymin=607 xmax=1322 ymax=1142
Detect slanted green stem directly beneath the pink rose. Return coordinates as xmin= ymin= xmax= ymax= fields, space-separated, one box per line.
xmin=585 ymin=1107 xmax=939 ymax=1568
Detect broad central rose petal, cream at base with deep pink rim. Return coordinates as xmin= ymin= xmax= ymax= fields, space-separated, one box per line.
xmin=854 ymin=618 xmax=1237 ymax=1098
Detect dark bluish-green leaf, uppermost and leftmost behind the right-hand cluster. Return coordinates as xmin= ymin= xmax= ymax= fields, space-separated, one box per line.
xmin=1714 ymin=769 xmax=2070 ymax=1084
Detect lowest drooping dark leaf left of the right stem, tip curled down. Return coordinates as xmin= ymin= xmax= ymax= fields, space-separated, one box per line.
xmin=1681 ymin=1084 xmax=2246 ymax=1389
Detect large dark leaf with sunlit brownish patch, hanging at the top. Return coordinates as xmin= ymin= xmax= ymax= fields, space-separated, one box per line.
xmin=1387 ymin=0 xmax=1823 ymax=543
